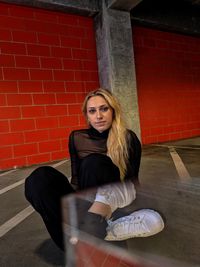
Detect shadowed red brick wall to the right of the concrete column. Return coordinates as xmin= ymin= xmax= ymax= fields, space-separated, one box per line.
xmin=133 ymin=27 xmax=200 ymax=144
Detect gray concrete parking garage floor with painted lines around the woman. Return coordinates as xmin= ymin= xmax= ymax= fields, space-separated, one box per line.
xmin=0 ymin=137 xmax=200 ymax=267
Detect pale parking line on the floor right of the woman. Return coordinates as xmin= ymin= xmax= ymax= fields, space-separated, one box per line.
xmin=169 ymin=146 xmax=191 ymax=180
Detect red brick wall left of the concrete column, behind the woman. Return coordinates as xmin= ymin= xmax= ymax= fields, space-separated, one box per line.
xmin=0 ymin=4 xmax=99 ymax=169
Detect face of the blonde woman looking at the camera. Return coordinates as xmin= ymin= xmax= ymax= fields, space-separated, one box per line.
xmin=87 ymin=96 xmax=113 ymax=133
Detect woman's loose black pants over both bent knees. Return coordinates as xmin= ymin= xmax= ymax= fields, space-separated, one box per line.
xmin=25 ymin=154 xmax=120 ymax=250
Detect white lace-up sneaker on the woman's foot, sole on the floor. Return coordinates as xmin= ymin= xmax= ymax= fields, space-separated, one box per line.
xmin=105 ymin=209 xmax=164 ymax=241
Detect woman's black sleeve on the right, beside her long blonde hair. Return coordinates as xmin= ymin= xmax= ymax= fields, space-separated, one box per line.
xmin=125 ymin=130 xmax=141 ymax=182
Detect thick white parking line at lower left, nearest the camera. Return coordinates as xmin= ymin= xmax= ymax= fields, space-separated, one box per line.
xmin=0 ymin=206 xmax=34 ymax=237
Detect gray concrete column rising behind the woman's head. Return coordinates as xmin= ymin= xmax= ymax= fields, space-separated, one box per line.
xmin=95 ymin=2 xmax=140 ymax=138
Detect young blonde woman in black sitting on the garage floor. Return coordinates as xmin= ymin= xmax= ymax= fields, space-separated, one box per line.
xmin=25 ymin=88 xmax=164 ymax=252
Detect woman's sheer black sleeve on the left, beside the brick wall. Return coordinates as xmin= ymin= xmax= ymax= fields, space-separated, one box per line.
xmin=68 ymin=132 xmax=80 ymax=187
